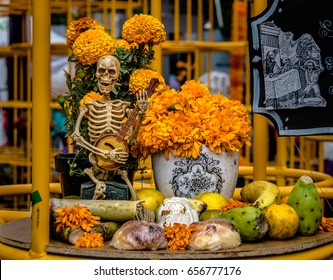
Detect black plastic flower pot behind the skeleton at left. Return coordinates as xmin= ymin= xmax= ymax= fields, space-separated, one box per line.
xmin=54 ymin=153 xmax=92 ymax=197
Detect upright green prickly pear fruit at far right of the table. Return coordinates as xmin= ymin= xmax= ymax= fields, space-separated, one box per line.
xmin=287 ymin=175 xmax=322 ymax=235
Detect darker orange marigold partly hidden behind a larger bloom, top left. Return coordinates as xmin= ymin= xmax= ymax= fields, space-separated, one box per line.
xmin=66 ymin=17 xmax=99 ymax=49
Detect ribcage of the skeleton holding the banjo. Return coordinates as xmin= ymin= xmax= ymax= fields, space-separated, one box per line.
xmin=85 ymin=100 xmax=130 ymax=142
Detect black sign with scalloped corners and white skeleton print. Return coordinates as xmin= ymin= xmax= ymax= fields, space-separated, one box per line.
xmin=249 ymin=0 xmax=333 ymax=136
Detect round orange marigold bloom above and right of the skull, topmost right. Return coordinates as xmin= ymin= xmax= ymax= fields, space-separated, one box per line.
xmin=122 ymin=14 xmax=166 ymax=45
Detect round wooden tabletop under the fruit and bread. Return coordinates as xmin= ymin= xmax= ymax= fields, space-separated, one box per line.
xmin=0 ymin=218 xmax=333 ymax=260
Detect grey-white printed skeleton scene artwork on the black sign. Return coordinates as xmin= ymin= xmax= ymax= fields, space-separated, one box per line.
xmin=259 ymin=22 xmax=326 ymax=110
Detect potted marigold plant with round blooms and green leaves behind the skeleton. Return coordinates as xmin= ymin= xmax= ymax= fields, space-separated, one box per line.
xmin=58 ymin=14 xmax=166 ymax=168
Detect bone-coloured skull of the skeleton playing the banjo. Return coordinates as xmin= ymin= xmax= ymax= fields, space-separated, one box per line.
xmin=96 ymin=55 xmax=120 ymax=94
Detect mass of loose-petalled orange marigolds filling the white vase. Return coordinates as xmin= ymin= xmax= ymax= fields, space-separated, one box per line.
xmin=132 ymin=80 xmax=252 ymax=161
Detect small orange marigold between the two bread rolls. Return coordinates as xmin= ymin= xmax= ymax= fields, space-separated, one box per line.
xmin=164 ymin=223 xmax=191 ymax=251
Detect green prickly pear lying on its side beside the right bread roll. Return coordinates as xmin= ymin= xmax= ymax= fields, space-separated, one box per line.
xmin=220 ymin=206 xmax=268 ymax=241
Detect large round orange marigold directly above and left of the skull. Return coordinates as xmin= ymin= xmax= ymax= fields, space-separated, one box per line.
xmin=73 ymin=26 xmax=115 ymax=65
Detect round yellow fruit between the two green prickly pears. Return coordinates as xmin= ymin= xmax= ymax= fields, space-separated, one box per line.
xmin=265 ymin=204 xmax=299 ymax=239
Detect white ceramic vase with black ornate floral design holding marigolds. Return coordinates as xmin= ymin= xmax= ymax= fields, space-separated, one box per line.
xmin=152 ymin=146 xmax=239 ymax=199
